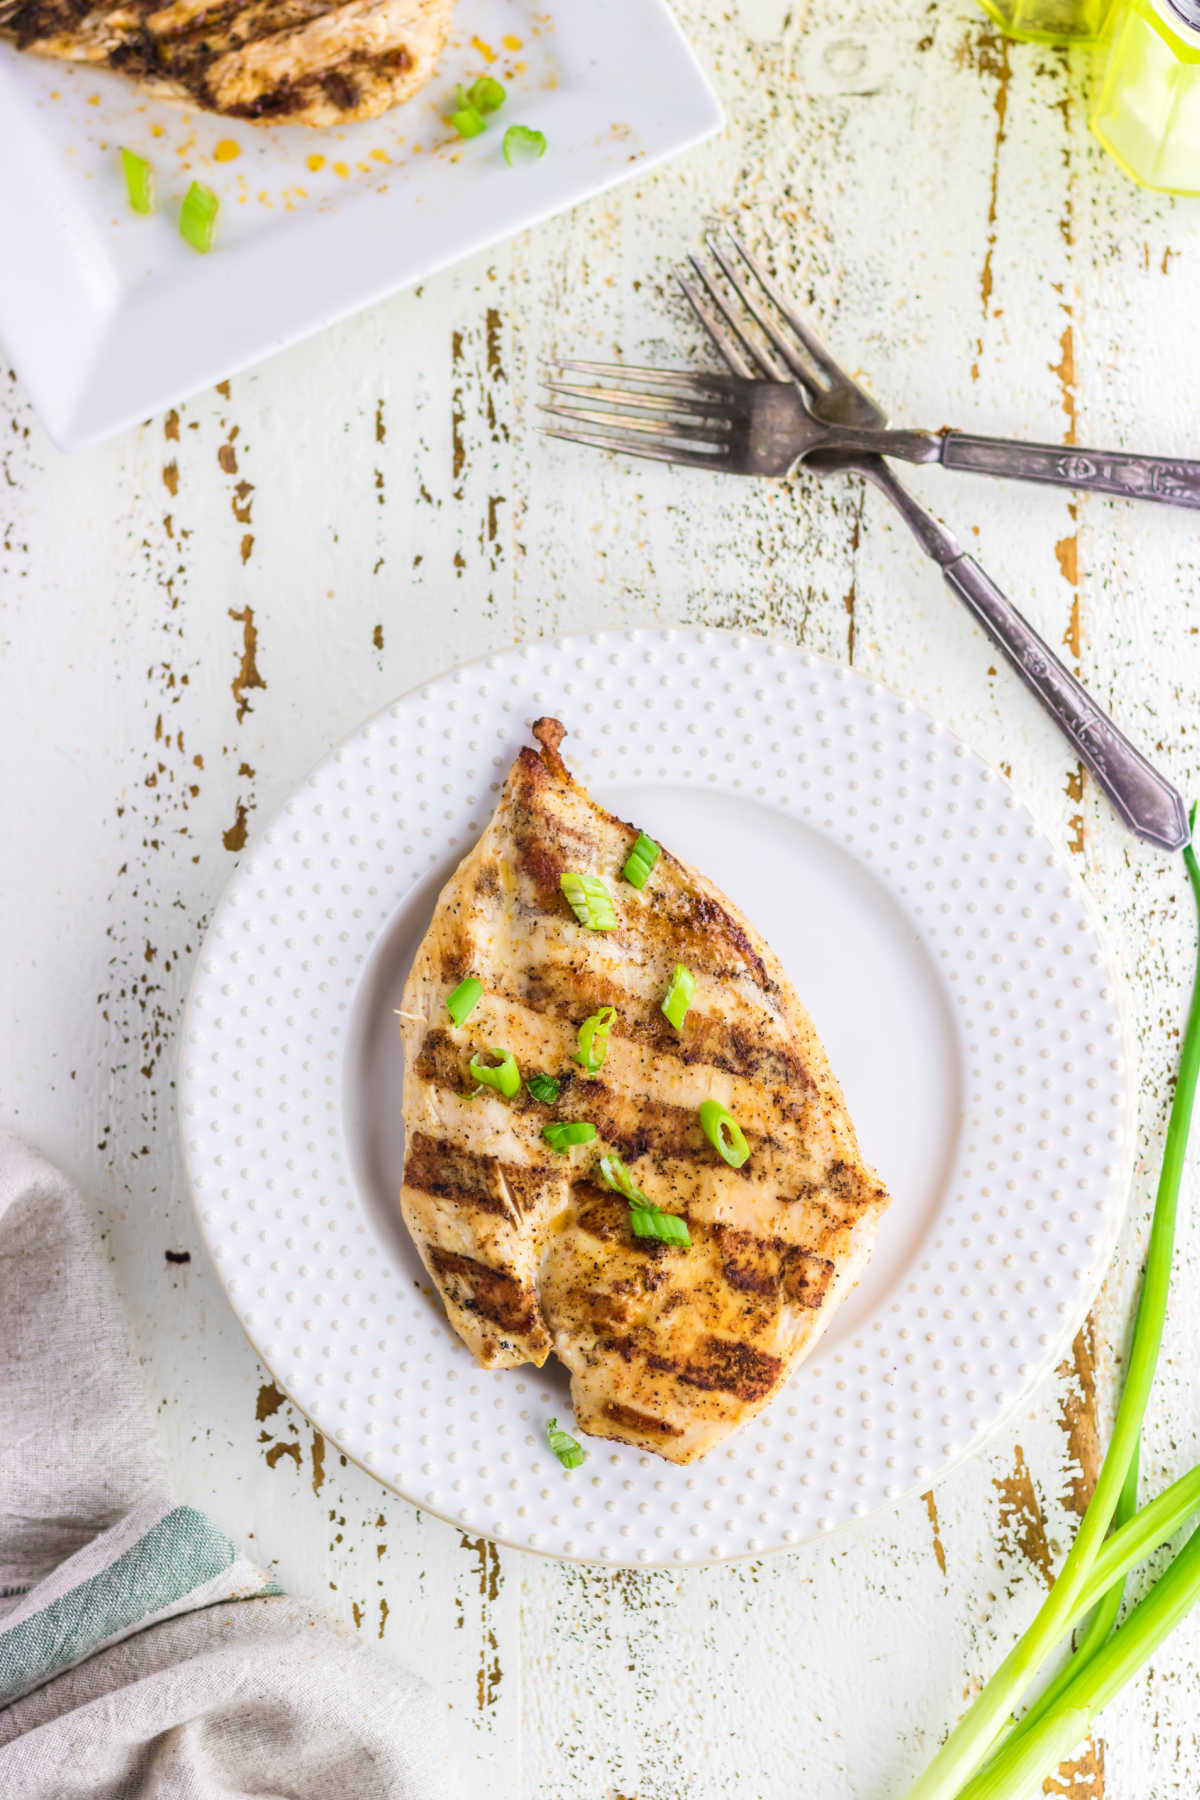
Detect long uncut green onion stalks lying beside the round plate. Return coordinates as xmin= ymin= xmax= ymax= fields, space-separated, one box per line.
xmin=907 ymin=835 xmax=1200 ymax=1800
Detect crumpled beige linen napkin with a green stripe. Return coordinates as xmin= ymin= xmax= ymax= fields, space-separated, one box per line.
xmin=0 ymin=1132 xmax=450 ymax=1800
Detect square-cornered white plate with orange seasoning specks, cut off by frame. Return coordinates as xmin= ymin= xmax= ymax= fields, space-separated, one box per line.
xmin=0 ymin=0 xmax=721 ymax=450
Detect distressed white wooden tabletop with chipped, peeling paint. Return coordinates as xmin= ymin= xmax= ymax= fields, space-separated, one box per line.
xmin=0 ymin=0 xmax=1200 ymax=1800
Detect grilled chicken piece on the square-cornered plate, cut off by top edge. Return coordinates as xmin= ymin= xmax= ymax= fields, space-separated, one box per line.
xmin=0 ymin=0 xmax=453 ymax=126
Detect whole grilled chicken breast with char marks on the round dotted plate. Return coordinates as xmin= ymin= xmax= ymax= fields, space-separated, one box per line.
xmin=401 ymin=720 xmax=889 ymax=1463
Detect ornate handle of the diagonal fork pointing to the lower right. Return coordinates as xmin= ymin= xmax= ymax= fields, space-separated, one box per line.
xmin=943 ymin=556 xmax=1191 ymax=850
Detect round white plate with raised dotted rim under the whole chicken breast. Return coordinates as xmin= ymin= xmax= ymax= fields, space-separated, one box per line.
xmin=180 ymin=632 xmax=1133 ymax=1562
